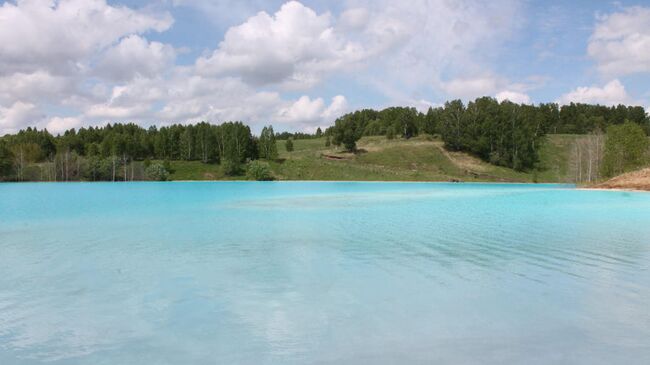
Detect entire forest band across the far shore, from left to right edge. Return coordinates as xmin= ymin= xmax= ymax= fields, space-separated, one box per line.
xmin=0 ymin=97 xmax=650 ymax=181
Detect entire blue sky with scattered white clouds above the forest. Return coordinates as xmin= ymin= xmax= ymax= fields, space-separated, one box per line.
xmin=0 ymin=0 xmax=650 ymax=135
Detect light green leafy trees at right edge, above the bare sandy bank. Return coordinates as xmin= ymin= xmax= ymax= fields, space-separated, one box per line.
xmin=602 ymin=121 xmax=648 ymax=177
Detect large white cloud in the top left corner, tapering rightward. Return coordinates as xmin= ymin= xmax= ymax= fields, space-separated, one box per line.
xmin=0 ymin=0 xmax=173 ymax=74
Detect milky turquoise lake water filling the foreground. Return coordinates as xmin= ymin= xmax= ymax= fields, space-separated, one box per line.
xmin=0 ymin=182 xmax=650 ymax=365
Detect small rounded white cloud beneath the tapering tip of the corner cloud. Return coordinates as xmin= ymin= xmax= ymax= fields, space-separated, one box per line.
xmin=97 ymin=34 xmax=176 ymax=80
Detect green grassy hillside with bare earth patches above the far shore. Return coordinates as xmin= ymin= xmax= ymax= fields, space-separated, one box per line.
xmin=166 ymin=135 xmax=576 ymax=182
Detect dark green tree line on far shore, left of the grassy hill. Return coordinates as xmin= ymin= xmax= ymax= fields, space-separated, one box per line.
xmin=0 ymin=122 xmax=260 ymax=181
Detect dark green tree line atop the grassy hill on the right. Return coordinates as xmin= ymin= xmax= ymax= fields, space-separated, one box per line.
xmin=326 ymin=97 xmax=650 ymax=170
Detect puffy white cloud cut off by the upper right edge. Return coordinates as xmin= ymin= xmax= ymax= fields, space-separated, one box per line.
xmin=588 ymin=6 xmax=650 ymax=76
